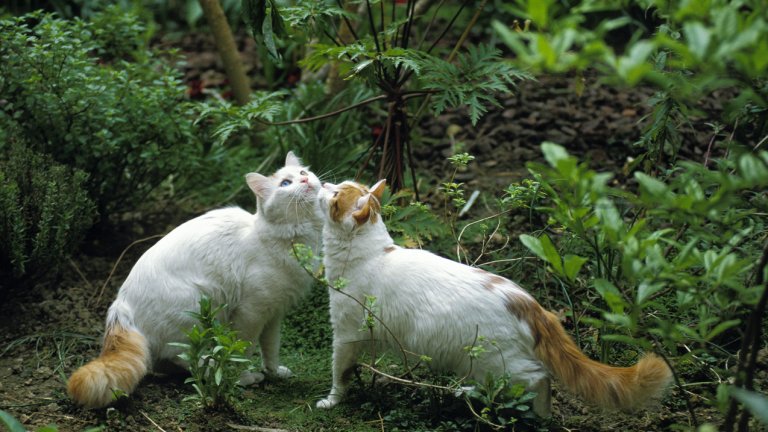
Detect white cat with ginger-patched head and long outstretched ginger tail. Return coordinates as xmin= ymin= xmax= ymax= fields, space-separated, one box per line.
xmin=317 ymin=180 xmax=671 ymax=416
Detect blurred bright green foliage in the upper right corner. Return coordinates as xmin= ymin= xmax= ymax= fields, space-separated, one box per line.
xmin=493 ymin=0 xmax=768 ymax=172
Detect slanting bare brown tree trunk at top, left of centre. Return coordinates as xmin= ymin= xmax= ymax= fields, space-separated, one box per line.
xmin=200 ymin=0 xmax=251 ymax=105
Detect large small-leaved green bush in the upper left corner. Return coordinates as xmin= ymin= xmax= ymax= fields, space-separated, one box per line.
xmin=0 ymin=10 xmax=199 ymax=218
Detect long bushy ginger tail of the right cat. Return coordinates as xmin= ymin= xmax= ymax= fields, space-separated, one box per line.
xmin=531 ymin=308 xmax=672 ymax=411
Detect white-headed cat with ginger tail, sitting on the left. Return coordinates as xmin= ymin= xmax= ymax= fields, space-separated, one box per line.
xmin=67 ymin=152 xmax=322 ymax=408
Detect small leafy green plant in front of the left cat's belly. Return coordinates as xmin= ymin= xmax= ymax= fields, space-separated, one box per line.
xmin=171 ymin=296 xmax=253 ymax=408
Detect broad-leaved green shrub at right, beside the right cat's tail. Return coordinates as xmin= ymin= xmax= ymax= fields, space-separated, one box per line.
xmin=520 ymin=143 xmax=768 ymax=426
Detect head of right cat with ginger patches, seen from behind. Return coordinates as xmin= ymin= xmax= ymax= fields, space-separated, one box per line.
xmin=318 ymin=180 xmax=386 ymax=230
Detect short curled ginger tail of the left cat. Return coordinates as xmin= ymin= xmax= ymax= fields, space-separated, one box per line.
xmin=67 ymin=324 xmax=149 ymax=408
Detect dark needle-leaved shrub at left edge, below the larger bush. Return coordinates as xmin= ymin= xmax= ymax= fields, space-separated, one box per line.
xmin=0 ymin=140 xmax=95 ymax=288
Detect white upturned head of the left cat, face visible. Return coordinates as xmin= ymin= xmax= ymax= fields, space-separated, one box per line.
xmin=245 ymin=152 xmax=322 ymax=223
